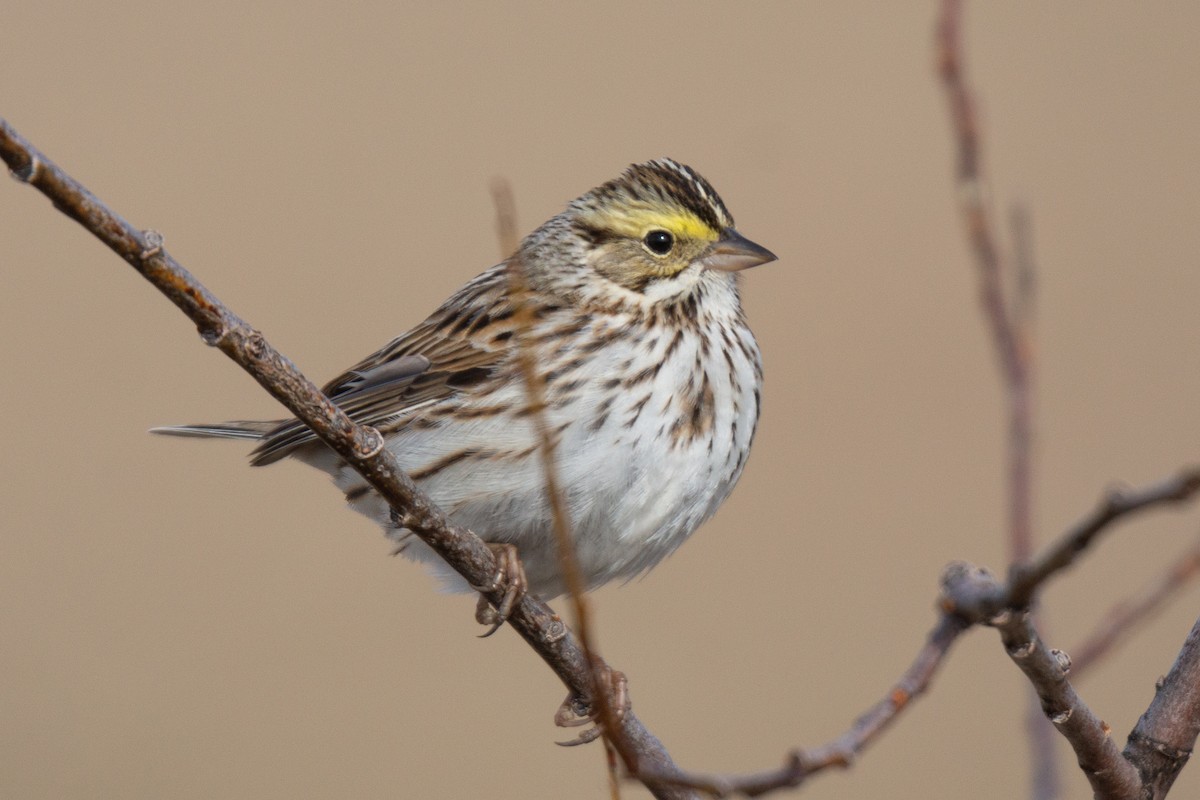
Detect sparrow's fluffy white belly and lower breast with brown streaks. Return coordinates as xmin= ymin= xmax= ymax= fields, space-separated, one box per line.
xmin=326 ymin=303 xmax=761 ymax=599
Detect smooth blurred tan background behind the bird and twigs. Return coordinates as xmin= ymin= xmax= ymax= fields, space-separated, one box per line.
xmin=0 ymin=1 xmax=1200 ymax=799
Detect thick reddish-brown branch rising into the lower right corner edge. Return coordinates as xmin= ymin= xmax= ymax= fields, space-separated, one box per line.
xmin=1124 ymin=619 xmax=1200 ymax=800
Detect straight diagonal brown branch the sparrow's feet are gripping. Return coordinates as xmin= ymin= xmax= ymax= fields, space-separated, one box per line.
xmin=0 ymin=119 xmax=692 ymax=798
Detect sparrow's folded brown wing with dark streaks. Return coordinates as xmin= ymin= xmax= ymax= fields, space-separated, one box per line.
xmin=251 ymin=264 xmax=512 ymax=467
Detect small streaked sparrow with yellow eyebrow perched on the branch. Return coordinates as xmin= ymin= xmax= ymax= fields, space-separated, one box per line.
xmin=156 ymin=158 xmax=775 ymax=599
